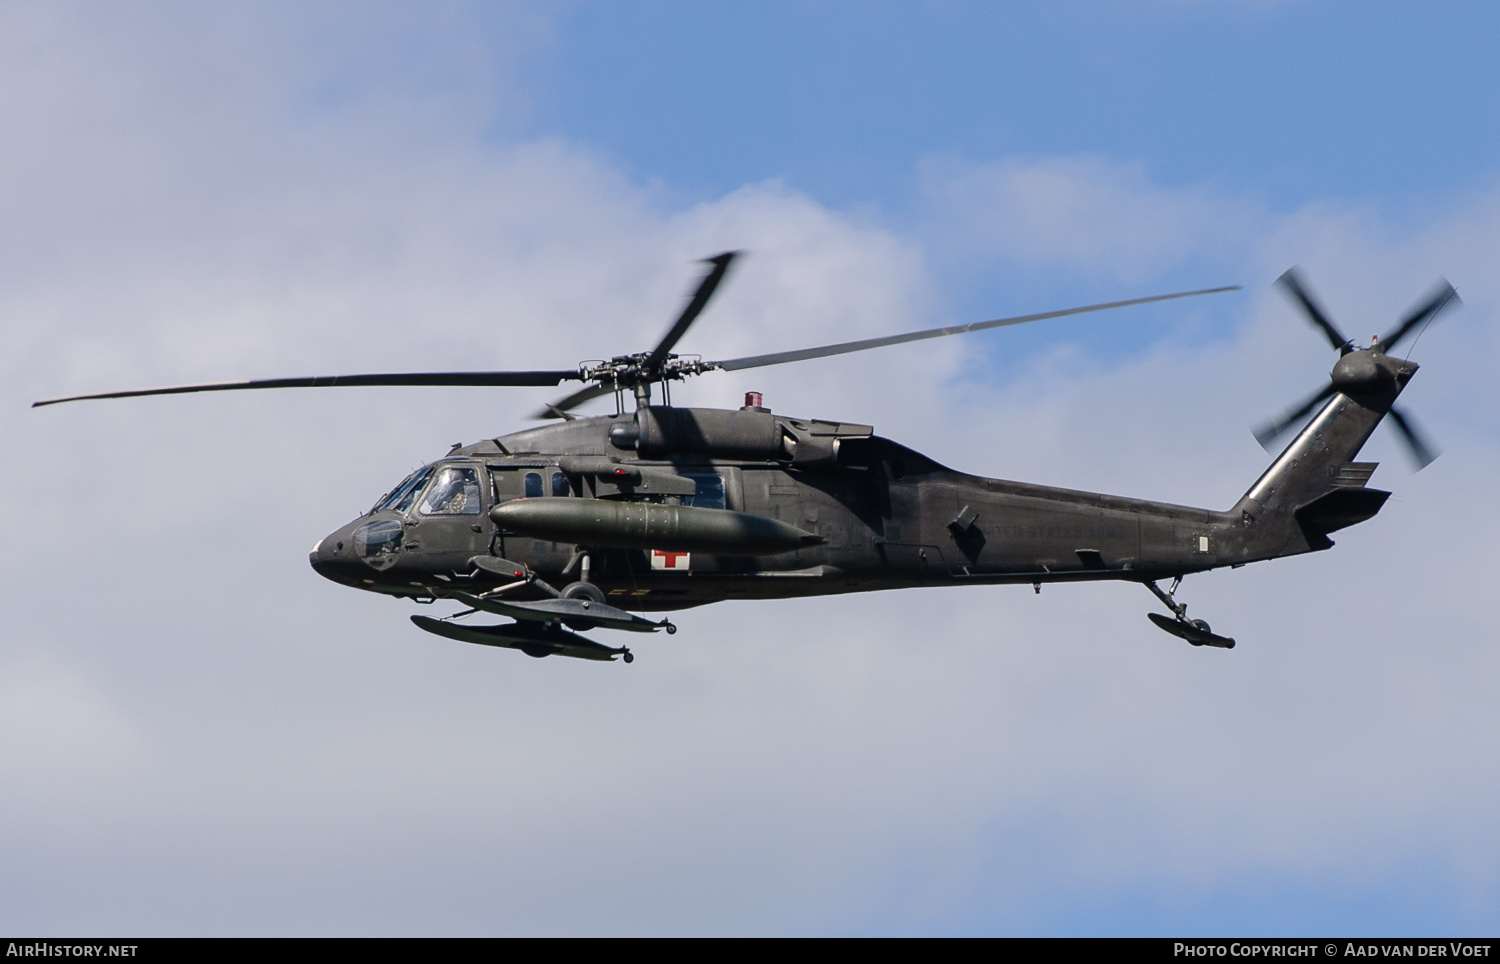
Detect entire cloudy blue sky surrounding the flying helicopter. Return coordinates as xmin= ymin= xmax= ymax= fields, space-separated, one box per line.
xmin=0 ymin=1 xmax=1500 ymax=936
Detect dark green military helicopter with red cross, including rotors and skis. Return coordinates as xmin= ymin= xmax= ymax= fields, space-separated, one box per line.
xmin=33 ymin=252 xmax=1460 ymax=663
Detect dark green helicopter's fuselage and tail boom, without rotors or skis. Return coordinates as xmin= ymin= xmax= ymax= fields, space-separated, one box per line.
xmin=311 ymin=382 xmax=1416 ymax=612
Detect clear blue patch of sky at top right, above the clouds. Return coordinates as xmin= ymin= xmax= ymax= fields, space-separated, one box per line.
xmin=540 ymin=1 xmax=1500 ymax=209
